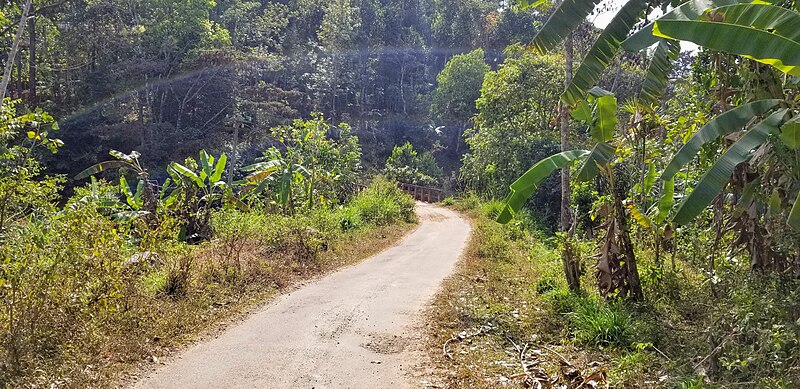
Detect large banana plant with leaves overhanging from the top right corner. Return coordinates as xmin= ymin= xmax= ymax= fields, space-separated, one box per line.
xmin=518 ymin=0 xmax=800 ymax=272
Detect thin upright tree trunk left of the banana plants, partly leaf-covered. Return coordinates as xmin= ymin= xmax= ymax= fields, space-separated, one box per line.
xmin=558 ymin=34 xmax=581 ymax=291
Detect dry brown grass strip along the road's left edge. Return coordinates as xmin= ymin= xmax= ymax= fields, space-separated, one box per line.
xmin=54 ymin=223 xmax=414 ymax=387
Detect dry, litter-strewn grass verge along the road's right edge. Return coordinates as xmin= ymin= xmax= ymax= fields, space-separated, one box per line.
xmin=418 ymin=205 xmax=624 ymax=388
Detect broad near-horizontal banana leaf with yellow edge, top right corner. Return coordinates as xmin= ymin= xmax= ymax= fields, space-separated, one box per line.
xmin=653 ymin=4 xmax=800 ymax=76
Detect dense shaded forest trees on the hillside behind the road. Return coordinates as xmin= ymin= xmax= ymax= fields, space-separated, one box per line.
xmin=0 ymin=0 xmax=542 ymax=177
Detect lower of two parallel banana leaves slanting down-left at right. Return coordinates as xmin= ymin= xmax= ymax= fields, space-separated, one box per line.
xmin=673 ymin=109 xmax=787 ymax=224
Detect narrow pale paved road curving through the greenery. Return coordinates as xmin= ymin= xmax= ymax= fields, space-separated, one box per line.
xmin=131 ymin=203 xmax=470 ymax=389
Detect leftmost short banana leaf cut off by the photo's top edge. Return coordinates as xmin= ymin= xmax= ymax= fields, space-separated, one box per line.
xmin=531 ymin=0 xmax=600 ymax=53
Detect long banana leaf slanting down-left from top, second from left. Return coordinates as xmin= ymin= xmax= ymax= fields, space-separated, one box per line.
xmin=561 ymin=0 xmax=648 ymax=105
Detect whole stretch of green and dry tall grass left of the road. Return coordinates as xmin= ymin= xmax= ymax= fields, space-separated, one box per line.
xmin=0 ymin=179 xmax=414 ymax=387
